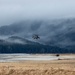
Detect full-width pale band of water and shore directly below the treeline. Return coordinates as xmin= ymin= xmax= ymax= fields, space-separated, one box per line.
xmin=0 ymin=54 xmax=75 ymax=62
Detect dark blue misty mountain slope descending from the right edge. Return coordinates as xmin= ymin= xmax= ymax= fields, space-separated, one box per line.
xmin=47 ymin=19 xmax=75 ymax=50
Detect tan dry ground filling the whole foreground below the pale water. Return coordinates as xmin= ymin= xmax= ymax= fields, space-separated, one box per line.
xmin=0 ymin=55 xmax=75 ymax=75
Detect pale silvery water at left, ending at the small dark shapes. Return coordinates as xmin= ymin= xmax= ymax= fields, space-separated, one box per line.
xmin=0 ymin=54 xmax=58 ymax=62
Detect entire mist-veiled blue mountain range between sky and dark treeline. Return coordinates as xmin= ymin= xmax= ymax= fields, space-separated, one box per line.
xmin=0 ymin=18 xmax=75 ymax=50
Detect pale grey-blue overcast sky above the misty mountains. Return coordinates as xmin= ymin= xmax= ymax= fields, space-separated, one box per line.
xmin=0 ymin=0 xmax=75 ymax=26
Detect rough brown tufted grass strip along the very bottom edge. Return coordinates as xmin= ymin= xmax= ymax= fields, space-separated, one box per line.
xmin=0 ymin=68 xmax=75 ymax=75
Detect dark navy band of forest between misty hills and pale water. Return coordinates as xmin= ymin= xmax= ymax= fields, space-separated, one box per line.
xmin=0 ymin=44 xmax=75 ymax=54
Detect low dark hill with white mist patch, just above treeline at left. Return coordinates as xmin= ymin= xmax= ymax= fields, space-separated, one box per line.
xmin=0 ymin=36 xmax=39 ymax=45
